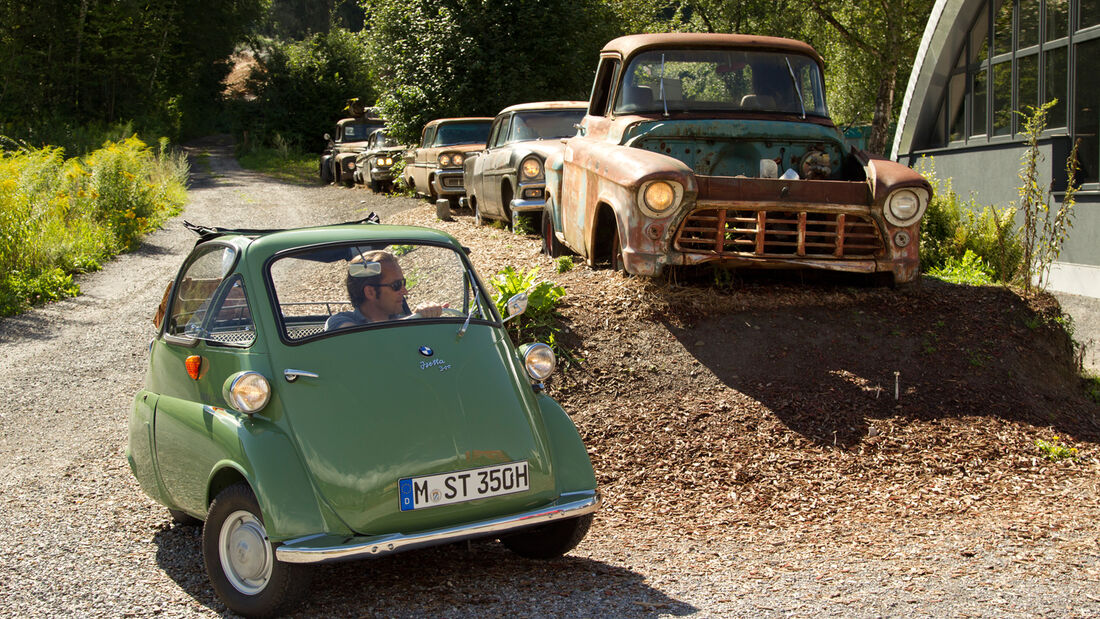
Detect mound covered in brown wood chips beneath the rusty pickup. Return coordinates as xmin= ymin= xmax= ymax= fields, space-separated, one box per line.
xmin=387 ymin=207 xmax=1100 ymax=529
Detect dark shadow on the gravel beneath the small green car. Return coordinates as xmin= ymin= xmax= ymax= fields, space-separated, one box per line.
xmin=153 ymin=524 xmax=699 ymax=618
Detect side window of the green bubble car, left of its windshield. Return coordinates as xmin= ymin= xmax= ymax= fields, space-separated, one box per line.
xmin=164 ymin=245 xmax=255 ymax=346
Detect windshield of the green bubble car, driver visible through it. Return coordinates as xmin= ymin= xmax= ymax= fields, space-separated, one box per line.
xmin=268 ymin=243 xmax=496 ymax=342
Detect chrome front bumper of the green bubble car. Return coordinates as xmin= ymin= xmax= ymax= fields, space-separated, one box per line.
xmin=275 ymin=490 xmax=600 ymax=563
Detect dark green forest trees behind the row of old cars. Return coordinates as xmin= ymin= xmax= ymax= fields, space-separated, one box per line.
xmin=0 ymin=0 xmax=933 ymax=155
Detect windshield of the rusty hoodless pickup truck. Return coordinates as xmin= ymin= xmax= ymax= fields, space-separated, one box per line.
xmin=615 ymin=49 xmax=828 ymax=118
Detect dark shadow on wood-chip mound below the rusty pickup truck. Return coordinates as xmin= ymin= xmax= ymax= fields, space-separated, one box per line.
xmin=666 ymin=273 xmax=1100 ymax=447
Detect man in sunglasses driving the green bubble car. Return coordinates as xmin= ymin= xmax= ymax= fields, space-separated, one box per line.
xmin=325 ymin=251 xmax=447 ymax=331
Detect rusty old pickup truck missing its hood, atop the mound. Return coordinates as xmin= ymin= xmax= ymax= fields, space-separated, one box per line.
xmin=542 ymin=34 xmax=932 ymax=284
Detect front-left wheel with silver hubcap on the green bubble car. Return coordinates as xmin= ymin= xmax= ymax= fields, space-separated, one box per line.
xmin=202 ymin=483 xmax=309 ymax=617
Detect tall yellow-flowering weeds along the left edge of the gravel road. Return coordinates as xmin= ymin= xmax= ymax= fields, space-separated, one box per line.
xmin=0 ymin=136 xmax=188 ymax=316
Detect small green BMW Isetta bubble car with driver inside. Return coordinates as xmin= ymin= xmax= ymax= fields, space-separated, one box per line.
xmin=125 ymin=222 xmax=600 ymax=616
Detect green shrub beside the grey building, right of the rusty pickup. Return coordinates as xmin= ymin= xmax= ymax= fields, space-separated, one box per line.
xmin=916 ymin=157 xmax=1023 ymax=283
